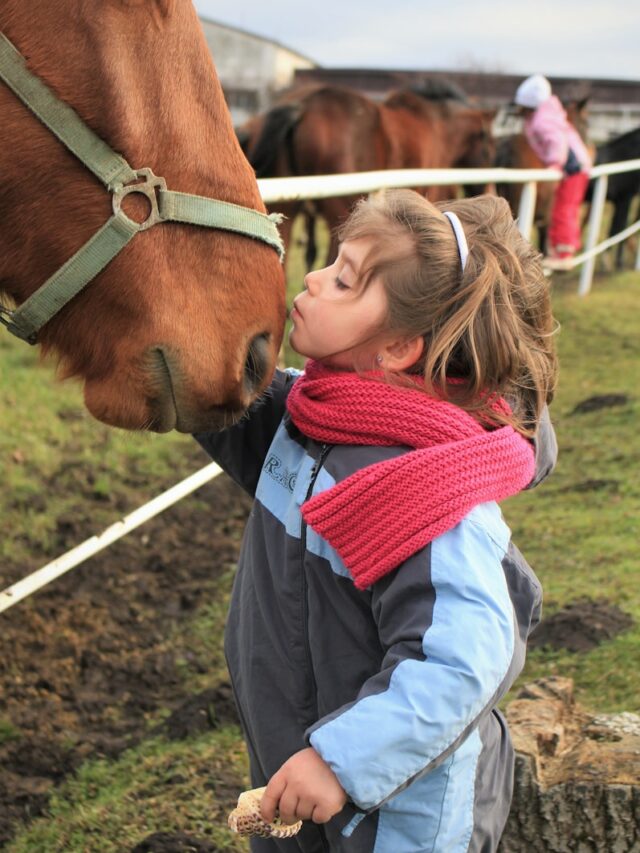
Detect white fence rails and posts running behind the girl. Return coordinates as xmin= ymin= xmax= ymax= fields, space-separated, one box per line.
xmin=0 ymin=159 xmax=640 ymax=613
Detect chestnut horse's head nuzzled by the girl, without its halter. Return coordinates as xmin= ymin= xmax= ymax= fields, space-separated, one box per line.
xmin=0 ymin=0 xmax=284 ymax=432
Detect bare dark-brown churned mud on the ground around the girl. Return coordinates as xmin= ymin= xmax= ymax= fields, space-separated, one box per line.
xmin=0 ymin=462 xmax=630 ymax=853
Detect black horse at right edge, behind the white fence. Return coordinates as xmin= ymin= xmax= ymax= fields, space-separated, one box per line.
xmin=586 ymin=127 xmax=640 ymax=269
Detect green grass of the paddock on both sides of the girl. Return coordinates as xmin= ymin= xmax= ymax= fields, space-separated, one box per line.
xmin=0 ymin=231 xmax=640 ymax=853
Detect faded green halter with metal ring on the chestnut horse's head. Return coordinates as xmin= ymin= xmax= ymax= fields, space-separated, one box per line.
xmin=0 ymin=33 xmax=284 ymax=344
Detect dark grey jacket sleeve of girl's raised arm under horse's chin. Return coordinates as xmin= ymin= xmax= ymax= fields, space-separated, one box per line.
xmin=194 ymin=370 xmax=299 ymax=496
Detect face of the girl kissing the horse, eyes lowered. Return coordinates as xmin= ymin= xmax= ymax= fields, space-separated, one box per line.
xmin=289 ymin=237 xmax=387 ymax=370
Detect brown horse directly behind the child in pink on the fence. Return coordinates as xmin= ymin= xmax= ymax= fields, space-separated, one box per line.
xmin=495 ymin=98 xmax=593 ymax=253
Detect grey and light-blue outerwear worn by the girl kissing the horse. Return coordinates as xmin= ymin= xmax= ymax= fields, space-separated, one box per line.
xmin=196 ymin=371 xmax=556 ymax=853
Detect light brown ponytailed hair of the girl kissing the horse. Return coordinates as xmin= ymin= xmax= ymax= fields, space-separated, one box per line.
xmin=339 ymin=190 xmax=557 ymax=435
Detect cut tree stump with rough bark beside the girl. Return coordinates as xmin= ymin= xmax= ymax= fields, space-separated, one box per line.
xmin=499 ymin=678 xmax=640 ymax=853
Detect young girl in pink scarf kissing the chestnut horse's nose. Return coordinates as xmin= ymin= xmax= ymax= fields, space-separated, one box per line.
xmin=198 ymin=190 xmax=556 ymax=853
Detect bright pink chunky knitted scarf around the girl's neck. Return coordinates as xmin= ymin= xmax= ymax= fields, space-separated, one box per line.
xmin=287 ymin=361 xmax=534 ymax=589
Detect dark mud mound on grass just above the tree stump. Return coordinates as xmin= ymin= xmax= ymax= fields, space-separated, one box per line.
xmin=529 ymin=598 xmax=633 ymax=652
